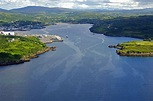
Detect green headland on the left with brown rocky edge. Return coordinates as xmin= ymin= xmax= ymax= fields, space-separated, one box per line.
xmin=0 ymin=35 xmax=61 ymax=66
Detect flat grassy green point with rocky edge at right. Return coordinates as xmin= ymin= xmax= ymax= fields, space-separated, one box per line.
xmin=109 ymin=41 xmax=153 ymax=57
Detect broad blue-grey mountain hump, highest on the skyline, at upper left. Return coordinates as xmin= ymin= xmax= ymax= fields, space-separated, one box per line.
xmin=10 ymin=6 xmax=73 ymax=13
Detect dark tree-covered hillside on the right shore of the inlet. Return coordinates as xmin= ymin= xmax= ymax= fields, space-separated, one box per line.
xmin=90 ymin=15 xmax=153 ymax=39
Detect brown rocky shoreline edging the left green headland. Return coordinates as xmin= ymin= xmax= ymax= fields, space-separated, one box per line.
xmin=0 ymin=46 xmax=56 ymax=66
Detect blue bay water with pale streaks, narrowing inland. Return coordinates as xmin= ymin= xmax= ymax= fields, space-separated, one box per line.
xmin=0 ymin=24 xmax=153 ymax=101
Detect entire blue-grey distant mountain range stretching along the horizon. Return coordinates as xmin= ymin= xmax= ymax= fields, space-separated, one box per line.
xmin=6 ymin=6 xmax=153 ymax=14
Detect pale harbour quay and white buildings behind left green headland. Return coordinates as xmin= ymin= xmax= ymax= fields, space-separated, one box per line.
xmin=0 ymin=31 xmax=63 ymax=44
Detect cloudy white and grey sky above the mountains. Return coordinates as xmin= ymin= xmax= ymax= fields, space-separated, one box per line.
xmin=0 ymin=0 xmax=153 ymax=9
